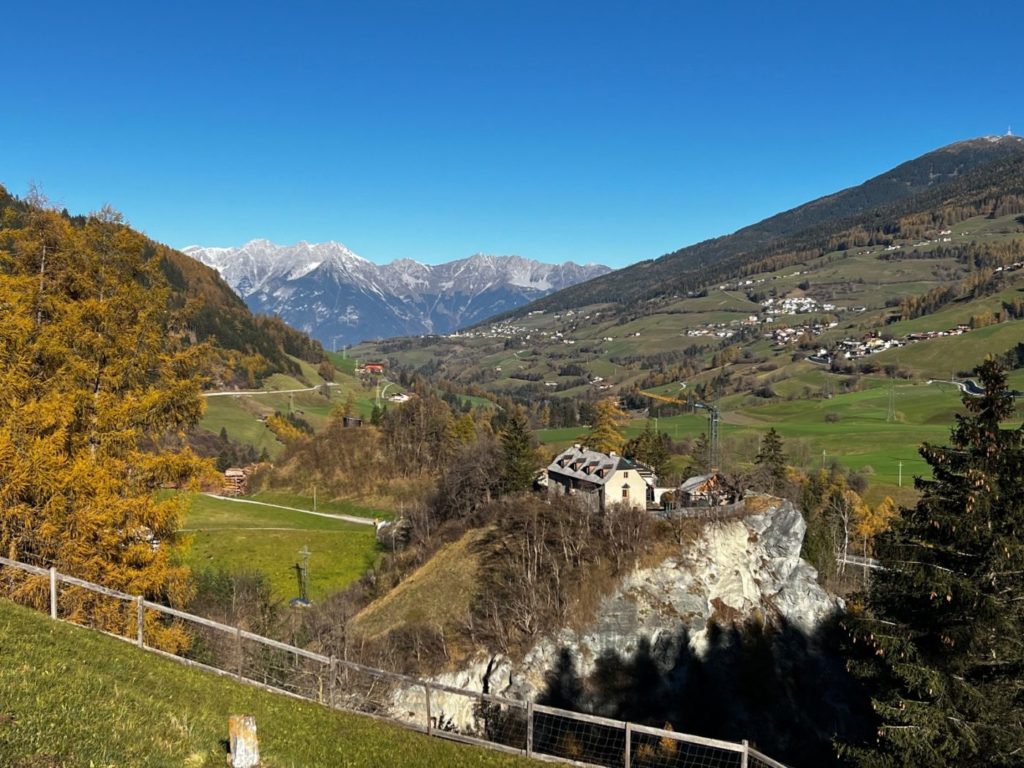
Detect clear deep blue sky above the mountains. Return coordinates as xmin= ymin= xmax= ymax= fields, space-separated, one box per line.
xmin=0 ymin=0 xmax=1024 ymax=266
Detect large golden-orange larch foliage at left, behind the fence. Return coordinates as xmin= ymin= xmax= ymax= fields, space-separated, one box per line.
xmin=0 ymin=196 xmax=208 ymax=649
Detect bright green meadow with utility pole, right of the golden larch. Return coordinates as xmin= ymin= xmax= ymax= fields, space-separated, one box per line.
xmin=182 ymin=496 xmax=377 ymax=600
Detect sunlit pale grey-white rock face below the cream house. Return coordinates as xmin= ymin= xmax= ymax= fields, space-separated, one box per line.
xmin=394 ymin=496 xmax=843 ymax=730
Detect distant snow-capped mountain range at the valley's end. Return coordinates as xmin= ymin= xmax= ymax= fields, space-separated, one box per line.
xmin=182 ymin=240 xmax=611 ymax=348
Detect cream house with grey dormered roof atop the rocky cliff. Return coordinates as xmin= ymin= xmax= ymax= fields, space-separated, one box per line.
xmin=547 ymin=444 xmax=657 ymax=512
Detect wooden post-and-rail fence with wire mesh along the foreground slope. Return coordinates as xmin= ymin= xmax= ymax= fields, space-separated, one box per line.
xmin=0 ymin=557 xmax=786 ymax=768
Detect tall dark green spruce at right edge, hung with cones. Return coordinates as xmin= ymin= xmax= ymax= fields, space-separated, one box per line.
xmin=850 ymin=360 xmax=1024 ymax=768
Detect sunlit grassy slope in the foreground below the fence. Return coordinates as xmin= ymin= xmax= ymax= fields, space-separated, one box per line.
xmin=0 ymin=601 xmax=537 ymax=768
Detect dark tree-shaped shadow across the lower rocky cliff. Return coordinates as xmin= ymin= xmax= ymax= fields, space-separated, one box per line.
xmin=538 ymin=620 xmax=873 ymax=768
